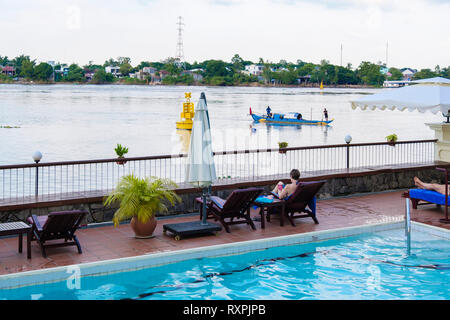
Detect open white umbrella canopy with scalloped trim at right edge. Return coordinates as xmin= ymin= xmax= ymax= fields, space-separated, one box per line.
xmin=352 ymin=77 xmax=450 ymax=116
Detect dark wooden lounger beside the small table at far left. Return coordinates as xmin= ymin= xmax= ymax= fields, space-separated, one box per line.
xmin=28 ymin=211 xmax=87 ymax=258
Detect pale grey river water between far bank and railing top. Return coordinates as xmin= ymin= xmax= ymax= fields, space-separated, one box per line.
xmin=0 ymin=84 xmax=442 ymax=165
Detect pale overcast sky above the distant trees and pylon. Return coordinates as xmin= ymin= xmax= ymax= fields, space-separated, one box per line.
xmin=0 ymin=0 xmax=450 ymax=68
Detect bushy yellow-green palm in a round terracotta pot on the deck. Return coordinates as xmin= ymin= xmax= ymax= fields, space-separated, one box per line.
xmin=104 ymin=174 xmax=181 ymax=239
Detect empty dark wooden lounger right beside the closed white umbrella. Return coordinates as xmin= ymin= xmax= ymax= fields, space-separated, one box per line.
xmin=196 ymin=188 xmax=264 ymax=232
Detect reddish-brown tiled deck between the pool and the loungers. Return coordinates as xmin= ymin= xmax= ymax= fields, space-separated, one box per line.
xmin=0 ymin=191 xmax=450 ymax=274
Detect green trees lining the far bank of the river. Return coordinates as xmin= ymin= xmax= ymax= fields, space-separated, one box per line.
xmin=0 ymin=54 xmax=450 ymax=86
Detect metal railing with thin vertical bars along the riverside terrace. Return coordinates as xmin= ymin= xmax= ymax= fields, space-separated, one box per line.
xmin=0 ymin=140 xmax=437 ymax=200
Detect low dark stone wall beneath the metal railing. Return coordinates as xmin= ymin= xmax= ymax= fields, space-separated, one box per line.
xmin=0 ymin=169 xmax=444 ymax=223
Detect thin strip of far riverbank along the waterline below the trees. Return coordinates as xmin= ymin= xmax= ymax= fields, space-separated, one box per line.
xmin=0 ymin=81 xmax=379 ymax=89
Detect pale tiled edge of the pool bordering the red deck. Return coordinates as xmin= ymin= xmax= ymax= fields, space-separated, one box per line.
xmin=0 ymin=219 xmax=444 ymax=290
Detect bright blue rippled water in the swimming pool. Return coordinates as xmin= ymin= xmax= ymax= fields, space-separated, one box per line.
xmin=0 ymin=230 xmax=450 ymax=300
